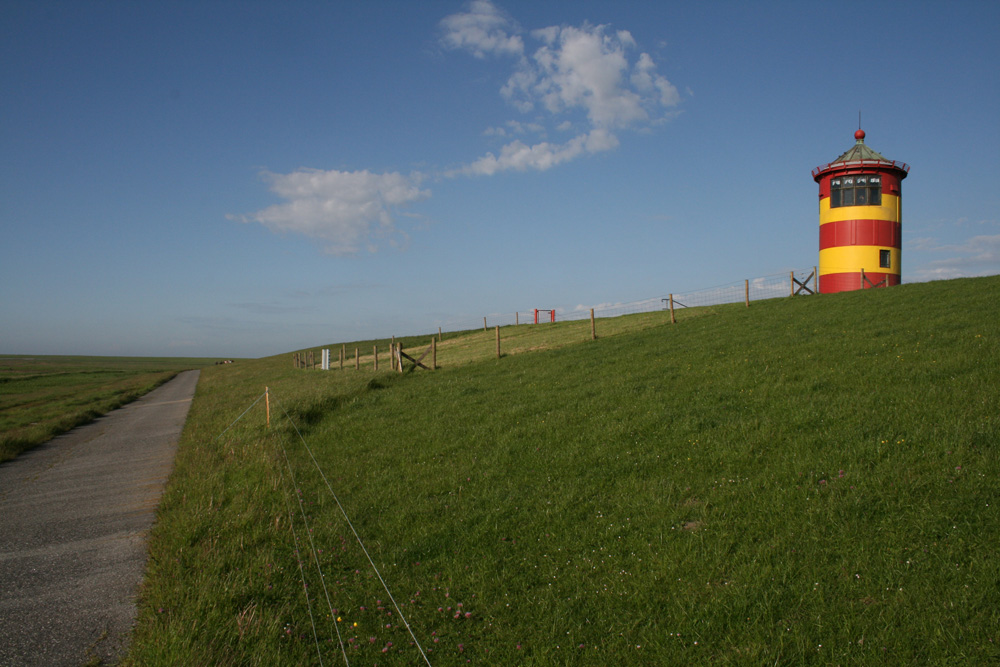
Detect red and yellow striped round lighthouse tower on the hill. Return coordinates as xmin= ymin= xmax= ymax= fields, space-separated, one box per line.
xmin=812 ymin=129 xmax=910 ymax=294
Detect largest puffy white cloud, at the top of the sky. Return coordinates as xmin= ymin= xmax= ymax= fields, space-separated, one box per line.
xmin=441 ymin=0 xmax=680 ymax=176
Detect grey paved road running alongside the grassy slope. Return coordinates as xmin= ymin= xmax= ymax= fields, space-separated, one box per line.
xmin=0 ymin=371 xmax=199 ymax=667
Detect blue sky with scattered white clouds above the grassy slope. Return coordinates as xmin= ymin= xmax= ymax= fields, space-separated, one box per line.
xmin=0 ymin=1 xmax=1000 ymax=357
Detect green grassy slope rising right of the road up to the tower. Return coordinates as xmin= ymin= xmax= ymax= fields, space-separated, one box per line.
xmin=127 ymin=277 xmax=1000 ymax=665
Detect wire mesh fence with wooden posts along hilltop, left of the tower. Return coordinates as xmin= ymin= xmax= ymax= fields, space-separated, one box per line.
xmin=474 ymin=267 xmax=818 ymax=328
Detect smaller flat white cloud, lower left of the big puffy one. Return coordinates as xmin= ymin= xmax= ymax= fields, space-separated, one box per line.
xmin=239 ymin=169 xmax=430 ymax=255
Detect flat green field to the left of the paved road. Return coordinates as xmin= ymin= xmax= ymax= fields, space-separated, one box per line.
xmin=0 ymin=355 xmax=216 ymax=461
